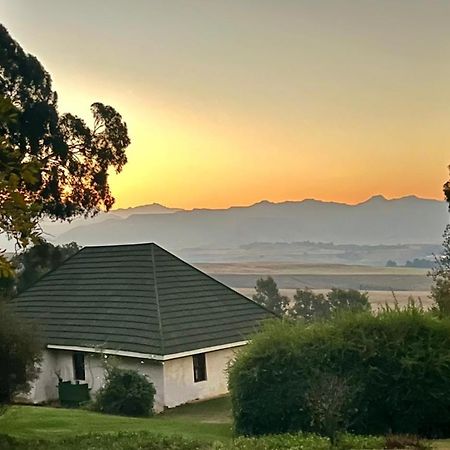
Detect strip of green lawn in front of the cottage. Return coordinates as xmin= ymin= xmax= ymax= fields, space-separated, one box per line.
xmin=0 ymin=397 xmax=232 ymax=442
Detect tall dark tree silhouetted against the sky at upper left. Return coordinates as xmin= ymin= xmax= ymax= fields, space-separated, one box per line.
xmin=0 ymin=25 xmax=130 ymax=234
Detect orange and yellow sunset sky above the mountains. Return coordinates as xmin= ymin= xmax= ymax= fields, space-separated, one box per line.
xmin=0 ymin=0 xmax=450 ymax=208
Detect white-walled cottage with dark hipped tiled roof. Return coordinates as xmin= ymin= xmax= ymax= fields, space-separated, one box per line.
xmin=9 ymin=244 xmax=272 ymax=410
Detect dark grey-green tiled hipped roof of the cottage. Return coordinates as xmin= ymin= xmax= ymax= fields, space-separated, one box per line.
xmin=12 ymin=244 xmax=273 ymax=355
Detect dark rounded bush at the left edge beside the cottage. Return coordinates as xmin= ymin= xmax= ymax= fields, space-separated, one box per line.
xmin=0 ymin=305 xmax=41 ymax=404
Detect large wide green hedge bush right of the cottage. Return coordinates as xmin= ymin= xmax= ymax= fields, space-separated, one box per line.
xmin=229 ymin=308 xmax=450 ymax=437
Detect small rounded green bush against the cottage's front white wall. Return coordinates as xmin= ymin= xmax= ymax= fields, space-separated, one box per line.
xmin=93 ymin=367 xmax=156 ymax=416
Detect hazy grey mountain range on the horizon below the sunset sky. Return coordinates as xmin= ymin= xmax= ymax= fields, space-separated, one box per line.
xmin=47 ymin=195 xmax=449 ymax=255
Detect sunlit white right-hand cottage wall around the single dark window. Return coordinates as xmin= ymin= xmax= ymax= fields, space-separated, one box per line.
xmin=164 ymin=347 xmax=244 ymax=408
